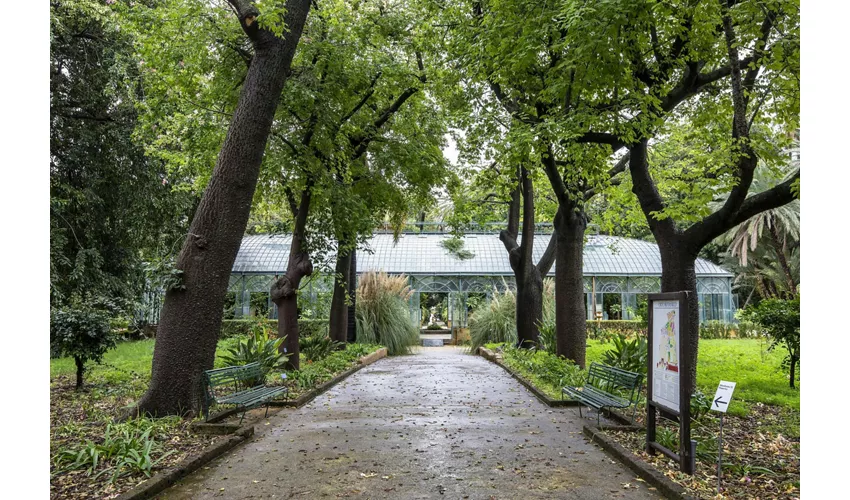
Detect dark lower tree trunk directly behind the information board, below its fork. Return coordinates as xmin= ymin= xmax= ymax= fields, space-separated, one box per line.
xmin=658 ymin=242 xmax=699 ymax=392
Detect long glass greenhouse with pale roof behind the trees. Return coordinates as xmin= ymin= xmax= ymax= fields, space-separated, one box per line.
xmin=228 ymin=232 xmax=737 ymax=328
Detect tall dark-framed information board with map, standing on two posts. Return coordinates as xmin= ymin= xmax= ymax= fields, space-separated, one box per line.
xmin=646 ymin=292 xmax=696 ymax=474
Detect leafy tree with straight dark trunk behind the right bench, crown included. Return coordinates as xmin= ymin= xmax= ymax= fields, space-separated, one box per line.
xmin=444 ymin=1 xmax=625 ymax=366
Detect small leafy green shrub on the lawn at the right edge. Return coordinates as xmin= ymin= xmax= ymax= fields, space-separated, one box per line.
xmin=744 ymin=295 xmax=800 ymax=388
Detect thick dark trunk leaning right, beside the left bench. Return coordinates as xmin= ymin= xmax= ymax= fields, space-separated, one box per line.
xmin=129 ymin=0 xmax=310 ymax=416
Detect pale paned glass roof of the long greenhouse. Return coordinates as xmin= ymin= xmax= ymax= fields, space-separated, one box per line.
xmin=233 ymin=233 xmax=732 ymax=276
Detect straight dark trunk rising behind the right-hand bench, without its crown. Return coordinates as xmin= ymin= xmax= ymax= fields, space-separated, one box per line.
xmin=553 ymin=205 xmax=587 ymax=368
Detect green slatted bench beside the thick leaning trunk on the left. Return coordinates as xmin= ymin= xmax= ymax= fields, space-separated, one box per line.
xmin=204 ymin=363 xmax=288 ymax=424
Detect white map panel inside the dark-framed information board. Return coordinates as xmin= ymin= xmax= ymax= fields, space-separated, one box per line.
xmin=652 ymin=300 xmax=680 ymax=411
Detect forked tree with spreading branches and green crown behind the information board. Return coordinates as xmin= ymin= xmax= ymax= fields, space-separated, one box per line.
xmin=568 ymin=2 xmax=799 ymax=388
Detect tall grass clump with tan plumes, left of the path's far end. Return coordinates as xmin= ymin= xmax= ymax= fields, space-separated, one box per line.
xmin=356 ymin=271 xmax=419 ymax=356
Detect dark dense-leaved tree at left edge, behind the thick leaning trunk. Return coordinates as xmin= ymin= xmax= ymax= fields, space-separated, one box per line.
xmin=50 ymin=0 xmax=193 ymax=308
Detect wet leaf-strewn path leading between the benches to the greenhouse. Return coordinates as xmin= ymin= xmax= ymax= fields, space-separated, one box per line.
xmin=161 ymin=347 xmax=660 ymax=499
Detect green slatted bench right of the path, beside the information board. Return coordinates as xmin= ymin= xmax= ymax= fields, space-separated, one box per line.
xmin=561 ymin=362 xmax=643 ymax=426
